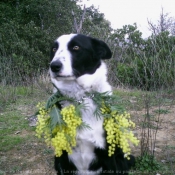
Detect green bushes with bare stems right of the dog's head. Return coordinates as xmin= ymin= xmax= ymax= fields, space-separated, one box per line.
xmin=113 ymin=25 xmax=175 ymax=90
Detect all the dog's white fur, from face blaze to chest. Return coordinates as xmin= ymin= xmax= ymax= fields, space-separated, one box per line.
xmin=50 ymin=35 xmax=111 ymax=175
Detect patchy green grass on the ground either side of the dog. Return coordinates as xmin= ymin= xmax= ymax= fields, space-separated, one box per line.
xmin=0 ymin=87 xmax=175 ymax=175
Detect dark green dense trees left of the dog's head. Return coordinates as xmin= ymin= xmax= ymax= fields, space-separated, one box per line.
xmin=0 ymin=0 xmax=78 ymax=84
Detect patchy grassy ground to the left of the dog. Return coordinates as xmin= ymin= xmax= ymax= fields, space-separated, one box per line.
xmin=0 ymin=87 xmax=53 ymax=175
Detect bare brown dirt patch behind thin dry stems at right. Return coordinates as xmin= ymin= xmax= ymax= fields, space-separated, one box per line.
xmin=131 ymin=106 xmax=175 ymax=156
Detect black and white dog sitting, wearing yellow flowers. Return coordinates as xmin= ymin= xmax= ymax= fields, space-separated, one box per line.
xmin=50 ymin=34 xmax=134 ymax=175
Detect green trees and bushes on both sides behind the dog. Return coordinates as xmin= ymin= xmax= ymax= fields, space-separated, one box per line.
xmin=0 ymin=0 xmax=175 ymax=90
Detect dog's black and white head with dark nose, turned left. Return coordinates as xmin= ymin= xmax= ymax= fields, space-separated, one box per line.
xmin=50 ymin=34 xmax=112 ymax=79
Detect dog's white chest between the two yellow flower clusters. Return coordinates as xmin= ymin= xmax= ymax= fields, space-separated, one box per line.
xmin=69 ymin=99 xmax=105 ymax=174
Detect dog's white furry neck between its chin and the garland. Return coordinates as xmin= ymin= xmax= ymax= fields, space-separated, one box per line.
xmin=51 ymin=62 xmax=111 ymax=99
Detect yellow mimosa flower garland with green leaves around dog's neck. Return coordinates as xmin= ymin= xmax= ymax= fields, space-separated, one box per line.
xmin=36 ymin=91 xmax=139 ymax=159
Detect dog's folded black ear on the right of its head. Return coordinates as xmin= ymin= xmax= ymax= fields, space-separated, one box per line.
xmin=92 ymin=38 xmax=112 ymax=59
